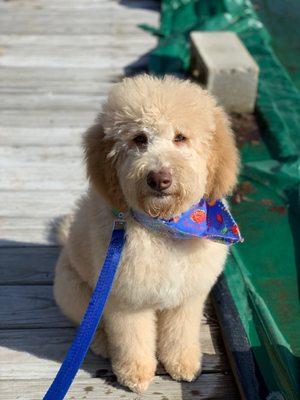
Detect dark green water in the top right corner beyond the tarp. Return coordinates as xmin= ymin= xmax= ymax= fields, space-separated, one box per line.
xmin=252 ymin=0 xmax=300 ymax=89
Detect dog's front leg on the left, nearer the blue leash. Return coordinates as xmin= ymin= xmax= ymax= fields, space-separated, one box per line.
xmin=105 ymin=307 xmax=156 ymax=393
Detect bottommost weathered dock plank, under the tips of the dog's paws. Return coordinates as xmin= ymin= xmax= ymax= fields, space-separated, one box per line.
xmin=0 ymin=373 xmax=240 ymax=400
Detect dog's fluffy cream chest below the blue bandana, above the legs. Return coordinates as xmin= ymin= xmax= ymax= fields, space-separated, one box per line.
xmin=113 ymin=228 xmax=226 ymax=309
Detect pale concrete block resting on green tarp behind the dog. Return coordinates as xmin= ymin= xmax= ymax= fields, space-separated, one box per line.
xmin=191 ymin=31 xmax=259 ymax=113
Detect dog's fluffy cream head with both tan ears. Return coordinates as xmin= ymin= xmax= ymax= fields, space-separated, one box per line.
xmin=84 ymin=75 xmax=239 ymax=218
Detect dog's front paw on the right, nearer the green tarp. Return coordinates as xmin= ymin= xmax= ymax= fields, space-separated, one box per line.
xmin=162 ymin=349 xmax=201 ymax=382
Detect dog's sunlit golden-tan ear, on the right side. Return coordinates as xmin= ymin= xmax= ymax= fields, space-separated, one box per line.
xmin=206 ymin=107 xmax=239 ymax=200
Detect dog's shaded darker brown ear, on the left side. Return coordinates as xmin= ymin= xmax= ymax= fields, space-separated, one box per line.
xmin=83 ymin=123 xmax=126 ymax=211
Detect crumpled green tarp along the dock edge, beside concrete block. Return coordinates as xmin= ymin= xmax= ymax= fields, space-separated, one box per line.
xmin=144 ymin=0 xmax=300 ymax=400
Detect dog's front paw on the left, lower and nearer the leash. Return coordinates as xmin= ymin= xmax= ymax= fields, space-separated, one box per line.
xmin=113 ymin=360 xmax=156 ymax=394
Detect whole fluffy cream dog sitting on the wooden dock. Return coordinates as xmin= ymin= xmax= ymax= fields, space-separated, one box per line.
xmin=54 ymin=75 xmax=239 ymax=392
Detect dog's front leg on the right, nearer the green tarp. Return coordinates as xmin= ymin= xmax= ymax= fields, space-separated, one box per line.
xmin=158 ymin=296 xmax=204 ymax=382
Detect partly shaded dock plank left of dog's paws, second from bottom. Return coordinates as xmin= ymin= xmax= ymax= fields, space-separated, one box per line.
xmin=0 ymin=324 xmax=111 ymax=380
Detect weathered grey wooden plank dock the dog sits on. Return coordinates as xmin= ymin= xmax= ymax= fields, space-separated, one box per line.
xmin=0 ymin=0 xmax=239 ymax=400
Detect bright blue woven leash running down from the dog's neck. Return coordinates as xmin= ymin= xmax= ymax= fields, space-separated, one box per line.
xmin=43 ymin=221 xmax=125 ymax=400
